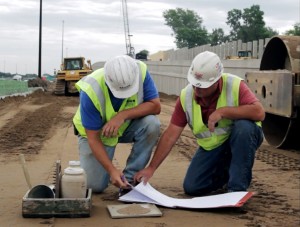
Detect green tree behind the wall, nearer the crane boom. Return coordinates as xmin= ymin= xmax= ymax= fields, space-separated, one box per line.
xmin=163 ymin=8 xmax=209 ymax=48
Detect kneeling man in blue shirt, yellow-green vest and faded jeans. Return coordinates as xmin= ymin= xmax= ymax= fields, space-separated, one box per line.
xmin=73 ymin=55 xmax=161 ymax=193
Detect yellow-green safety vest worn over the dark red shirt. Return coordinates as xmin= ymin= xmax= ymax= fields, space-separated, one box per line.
xmin=180 ymin=74 xmax=261 ymax=150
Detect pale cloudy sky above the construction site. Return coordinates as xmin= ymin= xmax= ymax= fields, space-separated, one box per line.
xmin=0 ymin=0 xmax=300 ymax=74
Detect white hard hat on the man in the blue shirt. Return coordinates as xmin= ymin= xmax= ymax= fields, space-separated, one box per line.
xmin=104 ymin=55 xmax=139 ymax=99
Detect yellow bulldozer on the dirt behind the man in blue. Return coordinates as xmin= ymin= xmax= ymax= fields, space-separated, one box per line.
xmin=54 ymin=57 xmax=93 ymax=96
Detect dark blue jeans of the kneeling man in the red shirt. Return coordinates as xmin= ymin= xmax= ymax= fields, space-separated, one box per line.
xmin=183 ymin=120 xmax=263 ymax=196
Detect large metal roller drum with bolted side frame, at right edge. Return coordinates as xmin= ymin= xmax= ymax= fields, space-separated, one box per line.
xmin=245 ymin=36 xmax=300 ymax=148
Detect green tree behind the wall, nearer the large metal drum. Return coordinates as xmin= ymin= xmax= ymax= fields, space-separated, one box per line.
xmin=226 ymin=5 xmax=278 ymax=42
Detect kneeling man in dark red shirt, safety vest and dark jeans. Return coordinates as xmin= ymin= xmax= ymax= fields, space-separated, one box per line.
xmin=134 ymin=51 xmax=265 ymax=196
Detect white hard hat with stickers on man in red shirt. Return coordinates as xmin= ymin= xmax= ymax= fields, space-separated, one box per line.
xmin=187 ymin=51 xmax=223 ymax=88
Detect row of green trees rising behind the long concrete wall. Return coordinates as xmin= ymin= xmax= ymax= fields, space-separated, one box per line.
xmin=163 ymin=5 xmax=300 ymax=48
